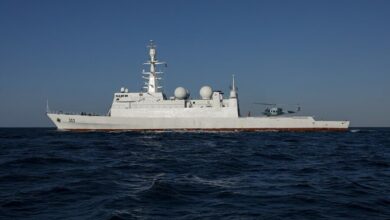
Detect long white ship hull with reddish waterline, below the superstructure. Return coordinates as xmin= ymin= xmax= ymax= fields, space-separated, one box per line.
xmin=48 ymin=113 xmax=349 ymax=131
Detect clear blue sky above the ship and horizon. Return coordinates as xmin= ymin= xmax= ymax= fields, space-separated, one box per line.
xmin=0 ymin=0 xmax=390 ymax=127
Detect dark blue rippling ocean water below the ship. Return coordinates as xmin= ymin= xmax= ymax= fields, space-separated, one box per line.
xmin=0 ymin=128 xmax=390 ymax=219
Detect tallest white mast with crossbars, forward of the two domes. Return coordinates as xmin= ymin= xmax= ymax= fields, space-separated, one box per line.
xmin=143 ymin=40 xmax=165 ymax=93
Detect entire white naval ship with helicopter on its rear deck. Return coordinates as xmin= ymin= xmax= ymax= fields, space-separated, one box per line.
xmin=46 ymin=41 xmax=350 ymax=131
